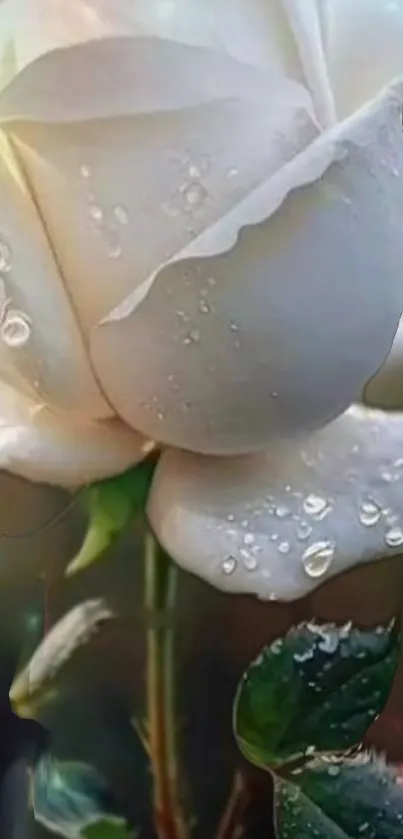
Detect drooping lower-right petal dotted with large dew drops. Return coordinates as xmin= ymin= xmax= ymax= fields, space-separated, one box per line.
xmin=148 ymin=407 xmax=403 ymax=600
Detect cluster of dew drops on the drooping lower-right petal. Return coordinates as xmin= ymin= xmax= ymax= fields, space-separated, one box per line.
xmin=221 ymin=482 xmax=403 ymax=600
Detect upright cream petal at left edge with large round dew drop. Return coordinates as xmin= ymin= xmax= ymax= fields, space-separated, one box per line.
xmin=0 ymin=133 xmax=112 ymax=417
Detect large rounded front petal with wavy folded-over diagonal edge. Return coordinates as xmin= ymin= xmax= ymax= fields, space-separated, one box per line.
xmin=91 ymin=86 xmax=403 ymax=454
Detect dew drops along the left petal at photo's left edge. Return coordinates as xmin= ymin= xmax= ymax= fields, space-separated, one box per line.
xmin=0 ymin=235 xmax=32 ymax=350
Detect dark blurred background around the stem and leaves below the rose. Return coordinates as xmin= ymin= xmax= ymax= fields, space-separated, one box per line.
xmin=0 ymin=475 xmax=403 ymax=839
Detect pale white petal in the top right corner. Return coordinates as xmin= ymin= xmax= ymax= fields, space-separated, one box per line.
xmin=324 ymin=0 xmax=403 ymax=117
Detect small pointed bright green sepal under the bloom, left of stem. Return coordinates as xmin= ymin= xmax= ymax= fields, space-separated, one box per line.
xmin=66 ymin=458 xmax=155 ymax=576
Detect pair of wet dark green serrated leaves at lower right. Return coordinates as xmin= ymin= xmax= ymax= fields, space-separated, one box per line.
xmin=234 ymin=623 xmax=403 ymax=839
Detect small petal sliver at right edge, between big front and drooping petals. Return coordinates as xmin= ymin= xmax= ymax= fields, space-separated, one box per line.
xmin=363 ymin=319 xmax=403 ymax=411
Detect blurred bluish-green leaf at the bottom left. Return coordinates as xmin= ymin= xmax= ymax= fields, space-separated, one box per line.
xmin=32 ymin=756 xmax=118 ymax=839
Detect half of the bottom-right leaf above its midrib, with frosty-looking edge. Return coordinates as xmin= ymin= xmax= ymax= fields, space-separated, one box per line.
xmin=295 ymin=755 xmax=403 ymax=839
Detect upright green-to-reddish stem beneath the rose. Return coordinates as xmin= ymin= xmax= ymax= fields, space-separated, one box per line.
xmin=145 ymin=533 xmax=189 ymax=839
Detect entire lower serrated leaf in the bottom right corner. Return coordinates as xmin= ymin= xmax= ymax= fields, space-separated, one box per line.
xmin=276 ymin=755 xmax=403 ymax=839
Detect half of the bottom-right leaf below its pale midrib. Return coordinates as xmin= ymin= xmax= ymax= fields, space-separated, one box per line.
xmin=276 ymin=779 xmax=348 ymax=839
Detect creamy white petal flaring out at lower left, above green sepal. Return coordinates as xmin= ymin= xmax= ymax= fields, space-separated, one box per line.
xmin=0 ymin=384 xmax=152 ymax=487
